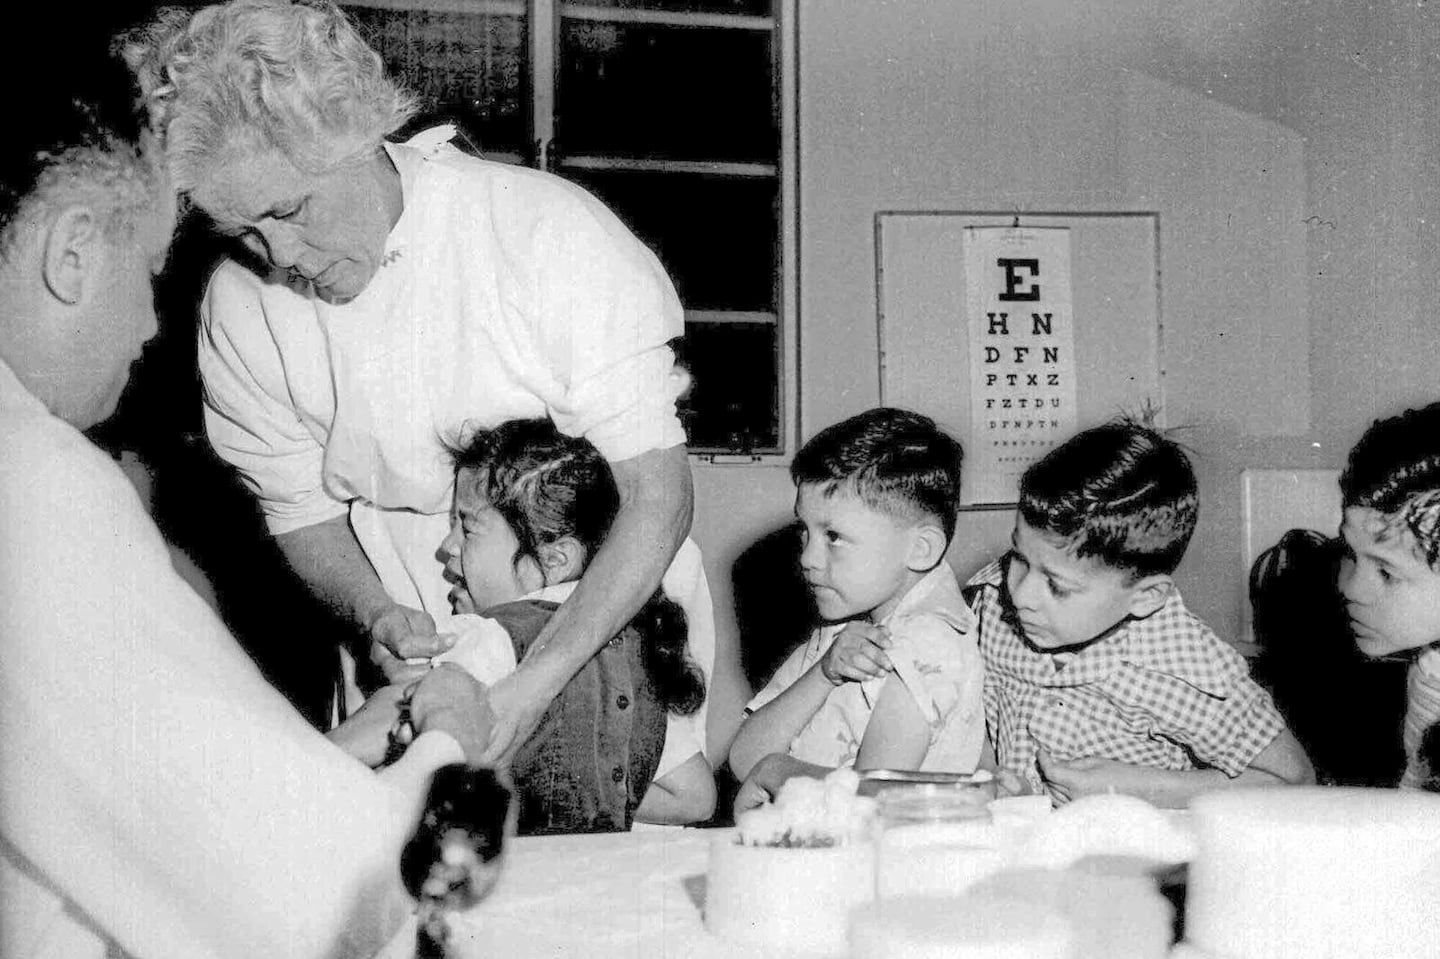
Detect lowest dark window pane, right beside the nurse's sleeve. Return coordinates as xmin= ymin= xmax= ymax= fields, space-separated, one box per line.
xmin=677 ymin=323 xmax=780 ymax=454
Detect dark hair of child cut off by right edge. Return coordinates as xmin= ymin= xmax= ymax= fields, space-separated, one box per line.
xmin=1341 ymin=403 xmax=1440 ymax=569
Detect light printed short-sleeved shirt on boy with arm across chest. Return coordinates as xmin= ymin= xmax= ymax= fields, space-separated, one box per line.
xmin=744 ymin=562 xmax=985 ymax=772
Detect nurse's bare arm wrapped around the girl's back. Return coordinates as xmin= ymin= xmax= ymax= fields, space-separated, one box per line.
xmin=485 ymin=446 xmax=694 ymax=763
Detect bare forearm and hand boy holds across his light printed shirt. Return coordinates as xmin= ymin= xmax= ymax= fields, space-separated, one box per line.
xmin=730 ymin=622 xmax=894 ymax=779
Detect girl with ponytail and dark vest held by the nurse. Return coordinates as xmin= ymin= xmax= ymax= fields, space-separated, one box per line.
xmin=436 ymin=419 xmax=716 ymax=835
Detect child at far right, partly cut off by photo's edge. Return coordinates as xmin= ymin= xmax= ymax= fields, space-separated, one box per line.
xmin=1339 ymin=403 xmax=1440 ymax=788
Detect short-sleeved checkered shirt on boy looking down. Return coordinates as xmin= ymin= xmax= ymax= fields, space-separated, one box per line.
xmin=966 ymin=560 xmax=1284 ymax=802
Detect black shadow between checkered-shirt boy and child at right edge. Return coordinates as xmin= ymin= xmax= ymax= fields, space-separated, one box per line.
xmin=1250 ymin=530 xmax=1407 ymax=786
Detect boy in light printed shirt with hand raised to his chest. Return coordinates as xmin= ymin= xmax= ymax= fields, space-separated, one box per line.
xmin=730 ymin=409 xmax=985 ymax=812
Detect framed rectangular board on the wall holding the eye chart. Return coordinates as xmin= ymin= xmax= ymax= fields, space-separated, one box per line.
xmin=876 ymin=212 xmax=1164 ymax=508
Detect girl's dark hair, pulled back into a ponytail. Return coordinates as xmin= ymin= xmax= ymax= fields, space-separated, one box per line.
xmin=454 ymin=419 xmax=706 ymax=716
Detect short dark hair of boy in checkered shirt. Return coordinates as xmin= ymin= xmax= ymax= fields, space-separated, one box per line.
xmin=1020 ymin=419 xmax=1200 ymax=579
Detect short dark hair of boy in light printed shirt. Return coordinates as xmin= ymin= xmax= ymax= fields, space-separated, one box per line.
xmin=791 ymin=406 xmax=965 ymax=541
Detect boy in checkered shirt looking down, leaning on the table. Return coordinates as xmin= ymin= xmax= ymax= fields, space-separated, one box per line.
xmin=966 ymin=420 xmax=1313 ymax=808
